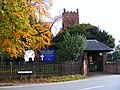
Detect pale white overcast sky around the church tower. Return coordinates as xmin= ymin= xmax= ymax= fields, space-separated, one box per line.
xmin=50 ymin=0 xmax=120 ymax=45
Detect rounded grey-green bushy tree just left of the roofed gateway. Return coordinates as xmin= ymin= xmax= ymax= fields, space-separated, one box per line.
xmin=55 ymin=32 xmax=87 ymax=61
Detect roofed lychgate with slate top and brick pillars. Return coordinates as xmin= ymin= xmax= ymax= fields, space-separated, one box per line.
xmin=83 ymin=40 xmax=113 ymax=75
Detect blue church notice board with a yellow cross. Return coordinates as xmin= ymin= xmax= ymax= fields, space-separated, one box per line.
xmin=39 ymin=49 xmax=54 ymax=61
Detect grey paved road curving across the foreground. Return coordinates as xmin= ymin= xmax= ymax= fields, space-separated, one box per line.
xmin=0 ymin=75 xmax=120 ymax=90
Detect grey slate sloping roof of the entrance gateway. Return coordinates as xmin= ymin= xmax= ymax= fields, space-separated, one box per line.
xmin=85 ymin=40 xmax=113 ymax=52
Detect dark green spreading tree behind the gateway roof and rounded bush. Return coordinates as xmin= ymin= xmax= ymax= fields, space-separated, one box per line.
xmin=54 ymin=24 xmax=115 ymax=48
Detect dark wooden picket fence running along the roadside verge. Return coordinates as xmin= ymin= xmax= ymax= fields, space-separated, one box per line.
xmin=0 ymin=61 xmax=82 ymax=80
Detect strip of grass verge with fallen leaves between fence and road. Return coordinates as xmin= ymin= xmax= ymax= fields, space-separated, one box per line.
xmin=0 ymin=74 xmax=87 ymax=87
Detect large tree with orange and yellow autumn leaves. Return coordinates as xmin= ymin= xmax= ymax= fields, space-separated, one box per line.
xmin=0 ymin=0 xmax=51 ymax=58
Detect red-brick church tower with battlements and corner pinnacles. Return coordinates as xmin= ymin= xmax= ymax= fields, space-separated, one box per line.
xmin=62 ymin=9 xmax=79 ymax=30
